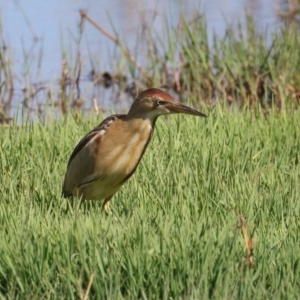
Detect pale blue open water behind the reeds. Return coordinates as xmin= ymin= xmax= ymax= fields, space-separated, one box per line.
xmin=1 ymin=0 xmax=279 ymax=116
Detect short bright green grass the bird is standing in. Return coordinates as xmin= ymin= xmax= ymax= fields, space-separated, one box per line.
xmin=0 ymin=110 xmax=300 ymax=299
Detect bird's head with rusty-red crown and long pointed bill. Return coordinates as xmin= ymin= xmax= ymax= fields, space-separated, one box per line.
xmin=128 ymin=88 xmax=206 ymax=119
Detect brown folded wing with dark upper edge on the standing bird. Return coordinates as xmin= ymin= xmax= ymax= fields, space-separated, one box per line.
xmin=62 ymin=114 xmax=123 ymax=197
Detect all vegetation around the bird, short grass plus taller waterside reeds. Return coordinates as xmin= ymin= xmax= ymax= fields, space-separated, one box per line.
xmin=0 ymin=7 xmax=300 ymax=299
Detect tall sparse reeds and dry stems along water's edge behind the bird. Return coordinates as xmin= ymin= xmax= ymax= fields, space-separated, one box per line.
xmin=0 ymin=7 xmax=300 ymax=123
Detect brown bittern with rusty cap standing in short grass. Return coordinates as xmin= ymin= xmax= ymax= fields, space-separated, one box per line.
xmin=62 ymin=88 xmax=207 ymax=214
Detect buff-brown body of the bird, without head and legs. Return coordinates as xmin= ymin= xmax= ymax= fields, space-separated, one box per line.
xmin=63 ymin=115 xmax=155 ymax=200
